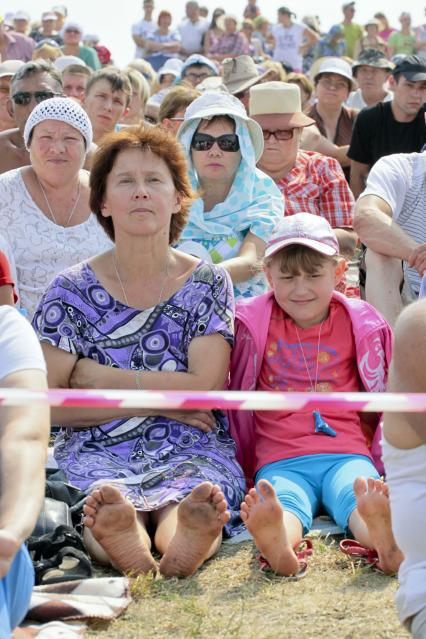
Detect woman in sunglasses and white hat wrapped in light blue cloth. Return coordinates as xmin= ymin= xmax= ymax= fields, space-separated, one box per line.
xmin=179 ymin=91 xmax=284 ymax=297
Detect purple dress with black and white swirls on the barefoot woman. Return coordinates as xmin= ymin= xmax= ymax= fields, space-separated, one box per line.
xmin=33 ymin=262 xmax=245 ymax=533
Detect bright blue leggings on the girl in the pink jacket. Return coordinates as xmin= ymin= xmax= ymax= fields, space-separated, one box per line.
xmin=256 ymin=454 xmax=380 ymax=534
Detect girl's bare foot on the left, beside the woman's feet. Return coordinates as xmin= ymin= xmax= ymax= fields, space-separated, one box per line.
xmin=241 ymin=479 xmax=300 ymax=577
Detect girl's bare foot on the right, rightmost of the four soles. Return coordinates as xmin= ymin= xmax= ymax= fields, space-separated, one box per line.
xmin=354 ymin=477 xmax=404 ymax=574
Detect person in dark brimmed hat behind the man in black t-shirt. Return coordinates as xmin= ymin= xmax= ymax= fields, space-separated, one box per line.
xmin=346 ymin=49 xmax=395 ymax=109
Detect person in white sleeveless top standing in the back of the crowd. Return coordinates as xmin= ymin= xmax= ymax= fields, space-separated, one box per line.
xmin=272 ymin=7 xmax=320 ymax=73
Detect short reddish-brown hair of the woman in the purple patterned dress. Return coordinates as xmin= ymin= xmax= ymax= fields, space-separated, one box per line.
xmin=90 ymin=127 xmax=196 ymax=244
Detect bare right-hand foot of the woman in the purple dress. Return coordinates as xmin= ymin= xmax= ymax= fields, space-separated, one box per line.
xmin=160 ymin=481 xmax=230 ymax=577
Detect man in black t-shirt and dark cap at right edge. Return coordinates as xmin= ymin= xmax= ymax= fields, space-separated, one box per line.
xmin=348 ymin=56 xmax=426 ymax=197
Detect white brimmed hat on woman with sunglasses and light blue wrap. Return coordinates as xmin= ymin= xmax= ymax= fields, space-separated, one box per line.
xmin=179 ymin=91 xmax=263 ymax=162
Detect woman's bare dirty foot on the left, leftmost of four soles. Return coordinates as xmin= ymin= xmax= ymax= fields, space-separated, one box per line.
xmin=83 ymin=485 xmax=157 ymax=575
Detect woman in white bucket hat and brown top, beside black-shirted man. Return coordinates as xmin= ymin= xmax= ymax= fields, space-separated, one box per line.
xmin=308 ymin=58 xmax=358 ymax=179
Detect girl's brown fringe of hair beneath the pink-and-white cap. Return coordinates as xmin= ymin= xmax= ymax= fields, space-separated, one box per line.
xmin=263 ymin=244 xmax=341 ymax=275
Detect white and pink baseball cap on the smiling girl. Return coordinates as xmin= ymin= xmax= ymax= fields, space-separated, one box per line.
xmin=265 ymin=213 xmax=339 ymax=257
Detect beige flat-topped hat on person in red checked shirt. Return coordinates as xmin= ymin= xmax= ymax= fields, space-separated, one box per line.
xmin=249 ymin=81 xmax=315 ymax=128
